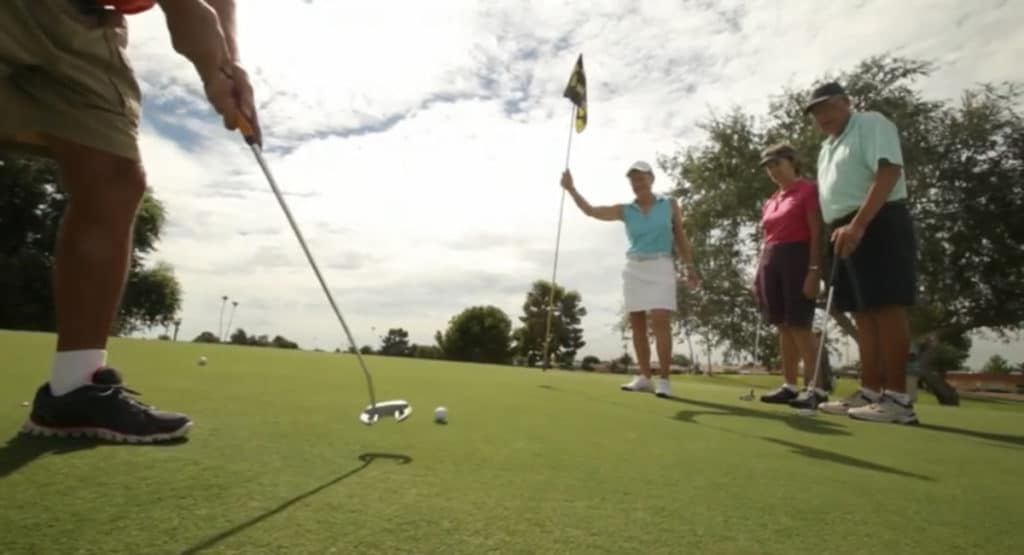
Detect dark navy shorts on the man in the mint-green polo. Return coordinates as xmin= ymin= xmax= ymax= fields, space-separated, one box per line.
xmin=828 ymin=201 xmax=918 ymax=312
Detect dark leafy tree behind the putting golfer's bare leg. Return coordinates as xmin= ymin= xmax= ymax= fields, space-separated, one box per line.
xmin=0 ymin=152 xmax=181 ymax=334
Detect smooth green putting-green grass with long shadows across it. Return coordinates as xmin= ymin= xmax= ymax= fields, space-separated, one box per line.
xmin=0 ymin=332 xmax=1024 ymax=554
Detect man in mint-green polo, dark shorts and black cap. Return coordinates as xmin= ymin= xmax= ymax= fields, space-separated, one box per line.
xmin=806 ymin=83 xmax=918 ymax=424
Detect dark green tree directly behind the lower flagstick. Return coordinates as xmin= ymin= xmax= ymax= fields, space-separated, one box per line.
xmin=514 ymin=280 xmax=587 ymax=368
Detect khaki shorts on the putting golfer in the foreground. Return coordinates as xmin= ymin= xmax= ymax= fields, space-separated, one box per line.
xmin=0 ymin=0 xmax=141 ymax=160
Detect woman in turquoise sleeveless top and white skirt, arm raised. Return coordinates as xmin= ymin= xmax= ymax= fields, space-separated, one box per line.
xmin=561 ymin=162 xmax=698 ymax=397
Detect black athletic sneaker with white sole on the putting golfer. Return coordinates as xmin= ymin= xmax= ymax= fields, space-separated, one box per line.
xmin=22 ymin=368 xmax=193 ymax=443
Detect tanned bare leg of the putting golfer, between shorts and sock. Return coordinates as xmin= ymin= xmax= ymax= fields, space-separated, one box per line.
xmin=50 ymin=139 xmax=145 ymax=351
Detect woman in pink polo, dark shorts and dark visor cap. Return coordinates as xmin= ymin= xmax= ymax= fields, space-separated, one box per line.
xmin=754 ymin=143 xmax=828 ymax=408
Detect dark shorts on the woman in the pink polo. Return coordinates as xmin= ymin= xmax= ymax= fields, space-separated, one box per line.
xmin=758 ymin=241 xmax=814 ymax=328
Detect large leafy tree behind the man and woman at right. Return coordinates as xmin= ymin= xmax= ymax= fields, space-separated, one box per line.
xmin=659 ymin=56 xmax=1024 ymax=403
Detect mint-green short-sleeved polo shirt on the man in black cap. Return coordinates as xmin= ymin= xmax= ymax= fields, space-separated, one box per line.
xmin=818 ymin=112 xmax=906 ymax=223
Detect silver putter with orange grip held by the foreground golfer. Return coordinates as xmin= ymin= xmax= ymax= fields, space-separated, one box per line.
xmin=234 ymin=114 xmax=413 ymax=425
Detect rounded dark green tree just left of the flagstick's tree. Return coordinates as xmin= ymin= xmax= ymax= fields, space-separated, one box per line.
xmin=434 ymin=306 xmax=512 ymax=364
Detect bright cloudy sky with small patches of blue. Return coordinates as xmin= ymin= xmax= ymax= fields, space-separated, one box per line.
xmin=130 ymin=0 xmax=1024 ymax=370
